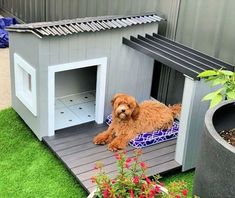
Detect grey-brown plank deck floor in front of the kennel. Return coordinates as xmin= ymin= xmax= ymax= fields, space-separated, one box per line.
xmin=43 ymin=122 xmax=180 ymax=192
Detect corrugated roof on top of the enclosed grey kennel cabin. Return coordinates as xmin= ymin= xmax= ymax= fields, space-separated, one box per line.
xmin=7 ymin=13 xmax=164 ymax=38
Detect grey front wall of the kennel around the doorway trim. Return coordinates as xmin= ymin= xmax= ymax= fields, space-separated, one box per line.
xmin=34 ymin=23 xmax=158 ymax=137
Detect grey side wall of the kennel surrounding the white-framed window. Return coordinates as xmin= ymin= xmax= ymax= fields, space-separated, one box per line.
xmin=10 ymin=33 xmax=43 ymax=138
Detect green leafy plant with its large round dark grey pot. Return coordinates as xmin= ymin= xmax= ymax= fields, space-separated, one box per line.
xmin=194 ymin=69 xmax=235 ymax=198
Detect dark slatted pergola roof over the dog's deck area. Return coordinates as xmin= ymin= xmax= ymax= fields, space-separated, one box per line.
xmin=123 ymin=33 xmax=233 ymax=79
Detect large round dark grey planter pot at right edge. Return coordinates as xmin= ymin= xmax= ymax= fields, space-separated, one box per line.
xmin=194 ymin=101 xmax=235 ymax=198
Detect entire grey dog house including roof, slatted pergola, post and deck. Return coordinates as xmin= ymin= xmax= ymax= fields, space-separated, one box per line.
xmin=8 ymin=14 xmax=231 ymax=191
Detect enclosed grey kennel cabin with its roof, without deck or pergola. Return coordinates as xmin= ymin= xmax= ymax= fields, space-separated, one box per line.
xmin=9 ymin=14 xmax=162 ymax=140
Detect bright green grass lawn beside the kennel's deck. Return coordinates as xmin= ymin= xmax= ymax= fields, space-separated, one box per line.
xmin=0 ymin=108 xmax=194 ymax=198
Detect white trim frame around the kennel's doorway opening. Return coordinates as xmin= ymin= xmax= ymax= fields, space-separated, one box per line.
xmin=48 ymin=57 xmax=107 ymax=136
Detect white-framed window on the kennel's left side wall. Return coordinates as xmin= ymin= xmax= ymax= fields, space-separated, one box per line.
xmin=14 ymin=54 xmax=37 ymax=116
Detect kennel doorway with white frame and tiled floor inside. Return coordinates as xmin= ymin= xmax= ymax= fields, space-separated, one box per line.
xmin=48 ymin=58 xmax=107 ymax=136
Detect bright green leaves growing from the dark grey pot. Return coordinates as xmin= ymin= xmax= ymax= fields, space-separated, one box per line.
xmin=198 ymin=69 xmax=235 ymax=108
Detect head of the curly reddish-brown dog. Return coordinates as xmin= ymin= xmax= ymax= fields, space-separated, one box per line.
xmin=111 ymin=93 xmax=139 ymax=120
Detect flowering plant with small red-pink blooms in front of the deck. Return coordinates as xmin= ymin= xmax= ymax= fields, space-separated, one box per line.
xmin=91 ymin=150 xmax=187 ymax=198
